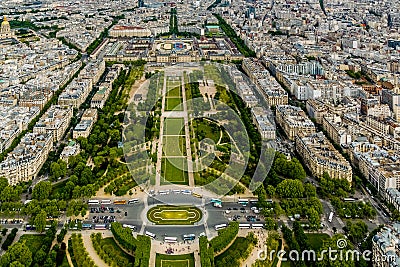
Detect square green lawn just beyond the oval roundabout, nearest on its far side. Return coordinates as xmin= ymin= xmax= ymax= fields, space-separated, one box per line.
xmin=161 ymin=157 xmax=189 ymax=185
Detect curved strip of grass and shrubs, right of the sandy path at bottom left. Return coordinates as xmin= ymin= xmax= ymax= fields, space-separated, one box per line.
xmin=90 ymin=233 xmax=134 ymax=267
